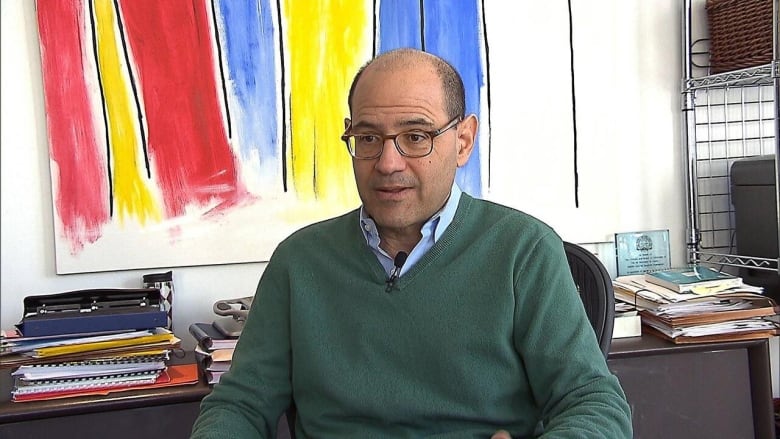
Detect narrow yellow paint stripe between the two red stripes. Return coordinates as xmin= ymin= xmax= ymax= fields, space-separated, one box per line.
xmin=94 ymin=0 xmax=161 ymax=225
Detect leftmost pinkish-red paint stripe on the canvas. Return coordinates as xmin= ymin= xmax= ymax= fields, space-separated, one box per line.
xmin=37 ymin=0 xmax=110 ymax=254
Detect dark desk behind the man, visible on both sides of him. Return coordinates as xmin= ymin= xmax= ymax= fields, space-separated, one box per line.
xmin=0 ymin=335 xmax=775 ymax=439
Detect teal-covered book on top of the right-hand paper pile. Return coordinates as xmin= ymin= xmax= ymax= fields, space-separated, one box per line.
xmin=645 ymin=266 xmax=742 ymax=294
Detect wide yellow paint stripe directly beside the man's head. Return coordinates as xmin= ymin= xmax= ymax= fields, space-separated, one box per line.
xmin=284 ymin=0 xmax=373 ymax=207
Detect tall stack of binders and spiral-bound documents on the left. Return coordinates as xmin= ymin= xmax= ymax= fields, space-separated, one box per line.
xmin=0 ymin=290 xmax=198 ymax=402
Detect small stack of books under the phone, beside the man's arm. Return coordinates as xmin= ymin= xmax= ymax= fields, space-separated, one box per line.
xmin=189 ymin=322 xmax=238 ymax=384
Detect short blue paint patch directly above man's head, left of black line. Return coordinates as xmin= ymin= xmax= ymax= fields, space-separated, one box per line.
xmin=376 ymin=0 xmax=422 ymax=53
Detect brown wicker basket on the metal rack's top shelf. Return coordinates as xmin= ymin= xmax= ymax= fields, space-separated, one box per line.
xmin=706 ymin=0 xmax=772 ymax=74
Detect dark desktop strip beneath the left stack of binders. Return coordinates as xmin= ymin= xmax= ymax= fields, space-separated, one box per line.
xmin=0 ymin=352 xmax=211 ymax=424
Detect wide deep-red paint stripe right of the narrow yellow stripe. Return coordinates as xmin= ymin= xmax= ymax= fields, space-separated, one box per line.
xmin=120 ymin=0 xmax=244 ymax=216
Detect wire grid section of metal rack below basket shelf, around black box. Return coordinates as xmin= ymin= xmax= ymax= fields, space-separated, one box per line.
xmin=692 ymin=77 xmax=777 ymax=270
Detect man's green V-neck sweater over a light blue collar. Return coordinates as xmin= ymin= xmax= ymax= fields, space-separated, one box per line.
xmin=193 ymin=194 xmax=631 ymax=439
